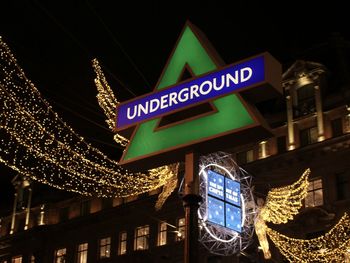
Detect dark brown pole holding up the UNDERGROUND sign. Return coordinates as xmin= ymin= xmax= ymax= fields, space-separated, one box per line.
xmin=182 ymin=151 xmax=202 ymax=263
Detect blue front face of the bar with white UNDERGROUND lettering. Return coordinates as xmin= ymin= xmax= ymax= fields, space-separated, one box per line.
xmin=116 ymin=55 xmax=266 ymax=130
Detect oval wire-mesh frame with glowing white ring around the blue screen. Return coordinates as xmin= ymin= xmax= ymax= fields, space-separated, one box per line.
xmin=198 ymin=152 xmax=256 ymax=256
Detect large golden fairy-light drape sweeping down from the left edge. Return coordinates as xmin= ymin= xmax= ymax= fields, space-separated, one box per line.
xmin=0 ymin=38 xmax=174 ymax=197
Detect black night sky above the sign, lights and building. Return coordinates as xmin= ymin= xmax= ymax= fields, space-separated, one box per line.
xmin=0 ymin=0 xmax=350 ymax=212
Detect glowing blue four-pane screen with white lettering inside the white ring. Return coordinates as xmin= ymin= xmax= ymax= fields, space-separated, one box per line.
xmin=207 ymin=170 xmax=242 ymax=233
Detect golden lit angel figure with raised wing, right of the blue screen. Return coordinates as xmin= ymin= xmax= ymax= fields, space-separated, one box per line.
xmin=255 ymin=169 xmax=310 ymax=259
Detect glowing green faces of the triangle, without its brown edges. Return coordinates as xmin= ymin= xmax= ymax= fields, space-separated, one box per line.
xmin=123 ymin=26 xmax=254 ymax=161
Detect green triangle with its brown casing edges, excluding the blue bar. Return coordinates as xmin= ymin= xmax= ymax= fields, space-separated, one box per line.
xmin=120 ymin=22 xmax=272 ymax=169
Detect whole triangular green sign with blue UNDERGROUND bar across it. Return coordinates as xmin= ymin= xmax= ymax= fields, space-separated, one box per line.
xmin=116 ymin=22 xmax=282 ymax=170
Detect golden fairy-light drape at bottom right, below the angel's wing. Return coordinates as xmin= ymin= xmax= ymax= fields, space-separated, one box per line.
xmin=267 ymin=213 xmax=350 ymax=262
